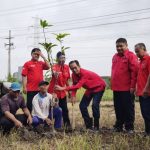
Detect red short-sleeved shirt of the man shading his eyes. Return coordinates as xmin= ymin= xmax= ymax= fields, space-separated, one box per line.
xmin=22 ymin=60 xmax=49 ymax=91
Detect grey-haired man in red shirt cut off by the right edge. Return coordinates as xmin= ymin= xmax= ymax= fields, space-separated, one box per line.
xmin=135 ymin=43 xmax=150 ymax=136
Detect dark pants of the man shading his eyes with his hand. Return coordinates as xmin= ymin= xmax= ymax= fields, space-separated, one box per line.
xmin=27 ymin=91 xmax=39 ymax=112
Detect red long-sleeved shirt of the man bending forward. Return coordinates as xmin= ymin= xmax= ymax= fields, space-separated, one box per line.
xmin=66 ymin=68 xmax=106 ymax=96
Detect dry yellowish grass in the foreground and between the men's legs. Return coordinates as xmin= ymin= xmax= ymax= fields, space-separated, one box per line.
xmin=0 ymin=101 xmax=150 ymax=150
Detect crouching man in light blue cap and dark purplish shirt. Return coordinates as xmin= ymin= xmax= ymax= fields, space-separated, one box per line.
xmin=0 ymin=82 xmax=32 ymax=134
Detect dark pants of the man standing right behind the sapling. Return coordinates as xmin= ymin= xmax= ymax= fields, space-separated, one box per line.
xmin=59 ymin=97 xmax=70 ymax=126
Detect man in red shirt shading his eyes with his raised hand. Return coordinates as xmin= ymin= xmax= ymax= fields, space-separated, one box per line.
xmin=22 ymin=48 xmax=50 ymax=112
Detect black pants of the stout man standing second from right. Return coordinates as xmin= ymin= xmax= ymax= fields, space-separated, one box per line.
xmin=113 ymin=91 xmax=135 ymax=130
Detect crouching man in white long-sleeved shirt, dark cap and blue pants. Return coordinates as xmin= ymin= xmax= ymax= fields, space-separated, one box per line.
xmin=32 ymin=81 xmax=62 ymax=130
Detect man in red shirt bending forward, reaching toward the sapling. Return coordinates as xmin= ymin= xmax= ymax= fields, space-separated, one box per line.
xmin=56 ymin=60 xmax=106 ymax=130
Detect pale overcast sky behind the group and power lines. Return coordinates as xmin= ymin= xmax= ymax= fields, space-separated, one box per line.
xmin=0 ymin=0 xmax=150 ymax=79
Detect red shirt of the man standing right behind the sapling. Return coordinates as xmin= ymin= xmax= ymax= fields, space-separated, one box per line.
xmin=48 ymin=64 xmax=70 ymax=99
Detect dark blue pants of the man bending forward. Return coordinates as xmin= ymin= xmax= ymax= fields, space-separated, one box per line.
xmin=79 ymin=91 xmax=104 ymax=128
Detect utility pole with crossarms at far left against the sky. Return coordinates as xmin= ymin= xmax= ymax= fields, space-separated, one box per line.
xmin=5 ymin=30 xmax=14 ymax=77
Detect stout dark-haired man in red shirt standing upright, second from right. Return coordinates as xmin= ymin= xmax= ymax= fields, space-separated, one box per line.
xmin=111 ymin=38 xmax=138 ymax=133
